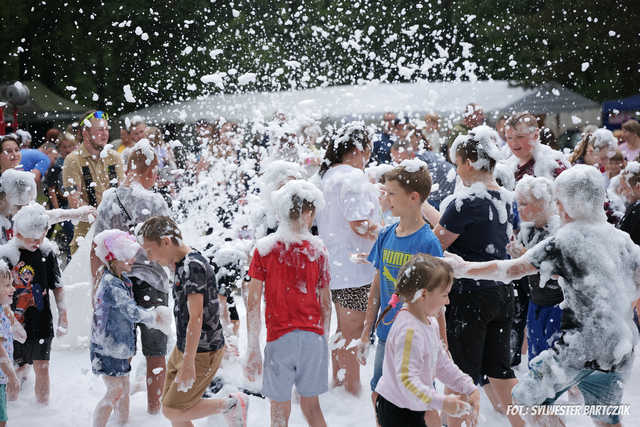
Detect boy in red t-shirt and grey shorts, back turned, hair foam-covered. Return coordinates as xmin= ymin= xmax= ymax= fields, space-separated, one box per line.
xmin=246 ymin=180 xmax=331 ymax=426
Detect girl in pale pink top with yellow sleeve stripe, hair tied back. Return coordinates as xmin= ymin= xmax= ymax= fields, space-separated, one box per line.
xmin=376 ymin=254 xmax=480 ymax=427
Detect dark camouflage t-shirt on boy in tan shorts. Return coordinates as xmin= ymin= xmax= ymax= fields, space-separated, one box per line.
xmin=173 ymin=250 xmax=224 ymax=353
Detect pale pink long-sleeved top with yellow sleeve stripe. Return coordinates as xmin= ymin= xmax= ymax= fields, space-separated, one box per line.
xmin=376 ymin=310 xmax=476 ymax=411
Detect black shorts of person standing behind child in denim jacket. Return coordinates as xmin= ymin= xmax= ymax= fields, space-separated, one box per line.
xmin=131 ymin=277 xmax=169 ymax=357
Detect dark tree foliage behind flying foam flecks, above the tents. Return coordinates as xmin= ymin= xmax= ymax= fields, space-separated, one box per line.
xmin=0 ymin=0 xmax=640 ymax=113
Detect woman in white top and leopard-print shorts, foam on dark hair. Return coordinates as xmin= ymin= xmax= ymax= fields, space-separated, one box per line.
xmin=317 ymin=122 xmax=381 ymax=395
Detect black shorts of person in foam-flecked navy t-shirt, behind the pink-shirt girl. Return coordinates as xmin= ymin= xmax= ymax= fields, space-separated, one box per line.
xmin=446 ymin=285 xmax=515 ymax=384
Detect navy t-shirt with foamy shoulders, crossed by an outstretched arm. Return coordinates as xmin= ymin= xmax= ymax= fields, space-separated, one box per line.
xmin=440 ymin=191 xmax=513 ymax=291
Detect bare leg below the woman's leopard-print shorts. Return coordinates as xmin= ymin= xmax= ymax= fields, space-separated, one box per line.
xmin=336 ymin=304 xmax=366 ymax=396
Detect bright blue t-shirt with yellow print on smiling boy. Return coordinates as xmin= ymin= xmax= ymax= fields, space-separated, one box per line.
xmin=367 ymin=224 xmax=442 ymax=341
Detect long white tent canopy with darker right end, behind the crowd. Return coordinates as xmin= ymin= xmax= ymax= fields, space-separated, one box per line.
xmin=125 ymin=80 xmax=600 ymax=125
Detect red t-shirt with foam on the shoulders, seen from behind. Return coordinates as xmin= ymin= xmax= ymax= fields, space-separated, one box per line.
xmin=249 ymin=240 xmax=329 ymax=341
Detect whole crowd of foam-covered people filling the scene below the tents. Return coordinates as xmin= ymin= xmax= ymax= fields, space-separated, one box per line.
xmin=0 ymin=104 xmax=640 ymax=427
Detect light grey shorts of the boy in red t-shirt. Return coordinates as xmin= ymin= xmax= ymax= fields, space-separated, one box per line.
xmin=262 ymin=330 xmax=329 ymax=402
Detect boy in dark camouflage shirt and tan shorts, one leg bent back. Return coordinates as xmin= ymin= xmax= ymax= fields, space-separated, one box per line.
xmin=138 ymin=216 xmax=248 ymax=427
